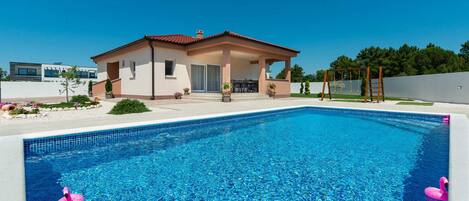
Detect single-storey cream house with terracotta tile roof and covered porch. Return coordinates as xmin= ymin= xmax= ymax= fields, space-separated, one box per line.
xmin=91 ymin=31 xmax=299 ymax=99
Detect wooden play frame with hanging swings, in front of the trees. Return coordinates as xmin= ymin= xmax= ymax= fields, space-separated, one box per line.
xmin=321 ymin=67 xmax=384 ymax=103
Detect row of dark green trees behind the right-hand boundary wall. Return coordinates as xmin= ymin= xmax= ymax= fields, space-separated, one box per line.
xmin=276 ymin=41 xmax=469 ymax=82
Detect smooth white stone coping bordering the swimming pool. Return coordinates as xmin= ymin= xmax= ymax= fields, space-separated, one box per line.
xmin=0 ymin=105 xmax=469 ymax=201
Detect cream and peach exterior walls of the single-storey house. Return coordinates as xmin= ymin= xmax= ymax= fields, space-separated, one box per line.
xmin=95 ymin=39 xmax=289 ymax=97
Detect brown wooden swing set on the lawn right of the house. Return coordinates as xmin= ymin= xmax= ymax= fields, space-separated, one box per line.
xmin=321 ymin=67 xmax=384 ymax=103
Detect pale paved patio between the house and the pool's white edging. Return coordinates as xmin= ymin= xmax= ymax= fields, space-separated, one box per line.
xmin=0 ymin=98 xmax=469 ymax=136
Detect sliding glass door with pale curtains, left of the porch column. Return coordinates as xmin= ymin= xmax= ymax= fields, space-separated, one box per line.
xmin=191 ymin=64 xmax=221 ymax=92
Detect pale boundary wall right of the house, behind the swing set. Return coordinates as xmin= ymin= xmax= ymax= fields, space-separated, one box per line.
xmin=291 ymin=72 xmax=469 ymax=104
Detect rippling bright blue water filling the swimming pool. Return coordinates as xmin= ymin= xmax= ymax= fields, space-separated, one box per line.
xmin=24 ymin=108 xmax=449 ymax=201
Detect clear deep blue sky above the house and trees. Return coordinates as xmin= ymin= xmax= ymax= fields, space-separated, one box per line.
xmin=0 ymin=0 xmax=469 ymax=73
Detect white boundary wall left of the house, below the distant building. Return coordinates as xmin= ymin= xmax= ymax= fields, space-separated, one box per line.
xmin=1 ymin=82 xmax=88 ymax=99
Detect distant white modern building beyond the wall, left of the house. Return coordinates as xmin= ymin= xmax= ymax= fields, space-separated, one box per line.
xmin=10 ymin=62 xmax=97 ymax=82
